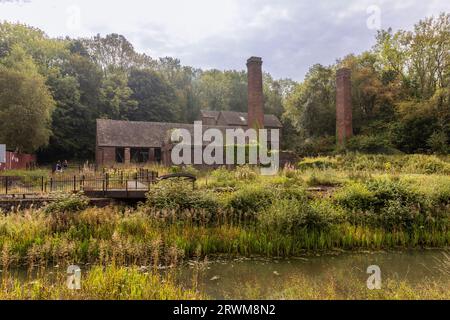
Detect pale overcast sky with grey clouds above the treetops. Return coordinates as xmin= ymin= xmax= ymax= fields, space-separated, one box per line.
xmin=0 ymin=0 xmax=450 ymax=80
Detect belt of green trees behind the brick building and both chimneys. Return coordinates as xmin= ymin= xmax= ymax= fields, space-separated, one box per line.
xmin=0 ymin=13 xmax=450 ymax=161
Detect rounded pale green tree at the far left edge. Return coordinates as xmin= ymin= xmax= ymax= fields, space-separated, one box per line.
xmin=0 ymin=47 xmax=55 ymax=152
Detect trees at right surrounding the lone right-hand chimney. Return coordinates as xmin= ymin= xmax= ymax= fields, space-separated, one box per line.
xmin=284 ymin=13 xmax=450 ymax=155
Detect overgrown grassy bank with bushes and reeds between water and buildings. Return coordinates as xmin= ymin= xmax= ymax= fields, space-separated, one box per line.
xmin=0 ymin=156 xmax=450 ymax=298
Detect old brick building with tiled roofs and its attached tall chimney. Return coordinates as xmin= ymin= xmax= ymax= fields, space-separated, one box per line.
xmin=96 ymin=57 xmax=282 ymax=165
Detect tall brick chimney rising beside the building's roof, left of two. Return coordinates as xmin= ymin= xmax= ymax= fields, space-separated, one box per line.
xmin=247 ymin=57 xmax=264 ymax=129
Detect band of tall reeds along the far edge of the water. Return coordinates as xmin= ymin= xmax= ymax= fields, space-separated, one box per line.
xmin=0 ymin=207 xmax=450 ymax=268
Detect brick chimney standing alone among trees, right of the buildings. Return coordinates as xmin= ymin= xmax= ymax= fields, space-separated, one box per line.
xmin=336 ymin=68 xmax=353 ymax=146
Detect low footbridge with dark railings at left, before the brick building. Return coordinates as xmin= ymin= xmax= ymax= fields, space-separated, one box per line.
xmin=0 ymin=169 xmax=196 ymax=200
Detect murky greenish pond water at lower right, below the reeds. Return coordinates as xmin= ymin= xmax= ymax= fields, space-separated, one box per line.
xmin=180 ymin=250 xmax=450 ymax=299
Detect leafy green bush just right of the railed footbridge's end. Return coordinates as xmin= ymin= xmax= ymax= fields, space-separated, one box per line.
xmin=147 ymin=181 xmax=219 ymax=213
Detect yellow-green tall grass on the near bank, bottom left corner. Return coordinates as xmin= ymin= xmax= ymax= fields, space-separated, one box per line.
xmin=0 ymin=265 xmax=205 ymax=300
